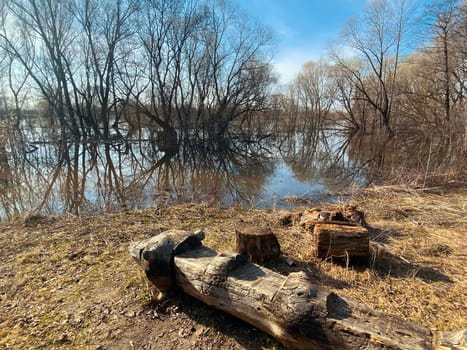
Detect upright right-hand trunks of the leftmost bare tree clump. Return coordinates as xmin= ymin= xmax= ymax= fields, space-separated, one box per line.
xmin=70 ymin=0 xmax=137 ymax=139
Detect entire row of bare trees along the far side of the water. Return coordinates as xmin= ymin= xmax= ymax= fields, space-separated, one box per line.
xmin=0 ymin=0 xmax=467 ymax=149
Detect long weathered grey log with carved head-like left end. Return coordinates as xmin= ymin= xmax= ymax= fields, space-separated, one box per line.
xmin=130 ymin=231 xmax=465 ymax=350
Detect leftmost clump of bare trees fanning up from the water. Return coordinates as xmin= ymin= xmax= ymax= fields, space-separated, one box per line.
xmin=0 ymin=0 xmax=136 ymax=138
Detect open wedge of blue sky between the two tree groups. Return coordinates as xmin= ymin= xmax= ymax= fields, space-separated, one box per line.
xmin=236 ymin=0 xmax=436 ymax=83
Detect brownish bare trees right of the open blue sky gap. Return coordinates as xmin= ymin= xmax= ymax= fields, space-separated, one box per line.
xmin=282 ymin=0 xmax=467 ymax=142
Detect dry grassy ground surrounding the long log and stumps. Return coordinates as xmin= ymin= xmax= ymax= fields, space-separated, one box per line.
xmin=0 ymin=184 xmax=467 ymax=350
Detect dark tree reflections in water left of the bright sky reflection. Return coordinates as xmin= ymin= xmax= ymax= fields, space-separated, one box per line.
xmin=0 ymin=129 xmax=280 ymax=218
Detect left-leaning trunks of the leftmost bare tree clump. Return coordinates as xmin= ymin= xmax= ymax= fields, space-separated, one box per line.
xmin=0 ymin=0 xmax=83 ymax=137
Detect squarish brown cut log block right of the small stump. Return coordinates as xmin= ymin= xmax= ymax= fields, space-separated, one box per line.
xmin=313 ymin=224 xmax=370 ymax=259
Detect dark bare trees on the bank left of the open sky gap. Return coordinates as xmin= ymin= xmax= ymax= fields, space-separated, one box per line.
xmin=0 ymin=0 xmax=274 ymax=139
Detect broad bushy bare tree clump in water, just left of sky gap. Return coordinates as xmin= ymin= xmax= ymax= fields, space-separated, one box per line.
xmin=134 ymin=0 xmax=272 ymax=142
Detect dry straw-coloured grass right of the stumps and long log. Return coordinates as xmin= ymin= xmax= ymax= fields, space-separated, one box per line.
xmin=330 ymin=186 xmax=467 ymax=330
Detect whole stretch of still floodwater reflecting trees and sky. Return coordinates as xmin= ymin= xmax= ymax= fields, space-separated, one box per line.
xmin=0 ymin=119 xmax=465 ymax=219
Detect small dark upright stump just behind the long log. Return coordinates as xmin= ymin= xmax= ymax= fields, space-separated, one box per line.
xmin=235 ymin=224 xmax=281 ymax=263
